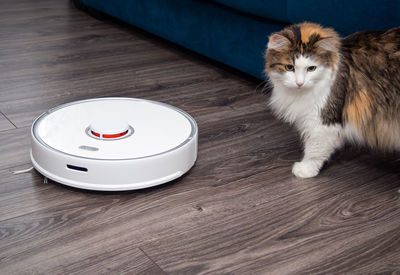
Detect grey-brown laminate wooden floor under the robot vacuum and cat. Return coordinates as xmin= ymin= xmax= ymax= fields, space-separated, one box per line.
xmin=0 ymin=0 xmax=400 ymax=274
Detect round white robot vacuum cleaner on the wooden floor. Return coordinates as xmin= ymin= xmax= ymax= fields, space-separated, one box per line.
xmin=31 ymin=98 xmax=198 ymax=191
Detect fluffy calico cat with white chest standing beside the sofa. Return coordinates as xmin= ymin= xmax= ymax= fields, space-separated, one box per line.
xmin=265 ymin=22 xmax=400 ymax=178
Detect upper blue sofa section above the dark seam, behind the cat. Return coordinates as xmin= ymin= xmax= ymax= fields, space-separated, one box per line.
xmin=213 ymin=0 xmax=400 ymax=36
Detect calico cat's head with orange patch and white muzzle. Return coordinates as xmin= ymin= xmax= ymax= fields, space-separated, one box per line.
xmin=265 ymin=22 xmax=340 ymax=91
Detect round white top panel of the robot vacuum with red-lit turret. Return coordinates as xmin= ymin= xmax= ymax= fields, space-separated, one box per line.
xmin=32 ymin=98 xmax=197 ymax=160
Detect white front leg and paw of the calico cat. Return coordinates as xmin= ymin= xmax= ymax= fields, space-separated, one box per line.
xmin=292 ymin=125 xmax=343 ymax=178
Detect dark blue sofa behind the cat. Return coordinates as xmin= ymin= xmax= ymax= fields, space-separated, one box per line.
xmin=77 ymin=0 xmax=400 ymax=78
